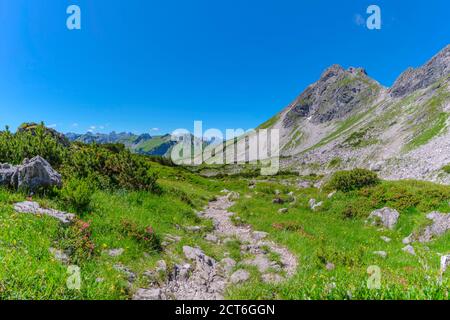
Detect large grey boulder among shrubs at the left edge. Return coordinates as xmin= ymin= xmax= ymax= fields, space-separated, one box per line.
xmin=0 ymin=156 xmax=62 ymax=191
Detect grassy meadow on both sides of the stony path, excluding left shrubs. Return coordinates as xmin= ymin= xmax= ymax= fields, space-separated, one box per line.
xmin=0 ymin=166 xmax=450 ymax=299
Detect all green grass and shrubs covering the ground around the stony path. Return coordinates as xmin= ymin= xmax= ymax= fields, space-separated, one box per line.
xmin=0 ymin=125 xmax=450 ymax=300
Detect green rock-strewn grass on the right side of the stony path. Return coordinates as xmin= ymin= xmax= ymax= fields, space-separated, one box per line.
xmin=225 ymin=182 xmax=450 ymax=299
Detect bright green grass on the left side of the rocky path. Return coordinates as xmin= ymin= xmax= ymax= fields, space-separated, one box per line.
xmin=0 ymin=162 xmax=227 ymax=299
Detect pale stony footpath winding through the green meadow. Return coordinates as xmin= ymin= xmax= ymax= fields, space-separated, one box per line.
xmin=133 ymin=196 xmax=297 ymax=300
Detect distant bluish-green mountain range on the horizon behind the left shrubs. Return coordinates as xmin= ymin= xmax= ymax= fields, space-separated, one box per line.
xmin=65 ymin=131 xmax=175 ymax=156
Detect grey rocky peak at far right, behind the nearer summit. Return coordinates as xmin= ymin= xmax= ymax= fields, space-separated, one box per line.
xmin=389 ymin=45 xmax=450 ymax=98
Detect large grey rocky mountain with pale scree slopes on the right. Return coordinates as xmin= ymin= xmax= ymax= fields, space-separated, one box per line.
xmin=261 ymin=45 xmax=450 ymax=183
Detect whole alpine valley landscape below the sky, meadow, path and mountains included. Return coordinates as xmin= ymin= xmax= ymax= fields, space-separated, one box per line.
xmin=0 ymin=46 xmax=450 ymax=300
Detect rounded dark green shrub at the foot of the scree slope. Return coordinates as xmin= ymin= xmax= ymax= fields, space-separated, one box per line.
xmin=326 ymin=169 xmax=380 ymax=192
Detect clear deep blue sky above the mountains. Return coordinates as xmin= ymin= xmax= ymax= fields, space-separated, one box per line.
xmin=0 ymin=0 xmax=450 ymax=134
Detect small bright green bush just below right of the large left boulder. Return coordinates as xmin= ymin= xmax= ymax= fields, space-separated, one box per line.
xmin=57 ymin=178 xmax=93 ymax=213
